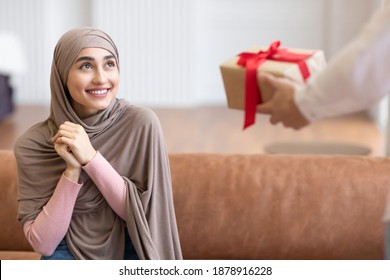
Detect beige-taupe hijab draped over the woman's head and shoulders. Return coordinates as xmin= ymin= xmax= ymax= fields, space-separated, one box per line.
xmin=15 ymin=27 xmax=182 ymax=259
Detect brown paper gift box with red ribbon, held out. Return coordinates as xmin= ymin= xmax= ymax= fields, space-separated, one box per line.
xmin=220 ymin=41 xmax=326 ymax=128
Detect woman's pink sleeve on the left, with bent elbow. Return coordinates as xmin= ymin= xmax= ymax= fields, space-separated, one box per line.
xmin=23 ymin=175 xmax=82 ymax=256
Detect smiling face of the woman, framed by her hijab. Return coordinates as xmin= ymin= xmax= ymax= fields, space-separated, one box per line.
xmin=66 ymin=48 xmax=119 ymax=118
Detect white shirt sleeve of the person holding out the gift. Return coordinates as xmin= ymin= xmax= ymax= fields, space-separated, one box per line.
xmin=294 ymin=1 xmax=390 ymax=122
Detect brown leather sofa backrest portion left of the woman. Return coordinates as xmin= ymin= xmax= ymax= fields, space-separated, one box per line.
xmin=0 ymin=150 xmax=32 ymax=251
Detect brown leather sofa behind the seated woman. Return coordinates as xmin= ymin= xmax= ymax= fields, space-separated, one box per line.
xmin=0 ymin=151 xmax=390 ymax=259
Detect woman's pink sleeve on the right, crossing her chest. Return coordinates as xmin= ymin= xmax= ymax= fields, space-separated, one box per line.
xmin=83 ymin=152 xmax=126 ymax=219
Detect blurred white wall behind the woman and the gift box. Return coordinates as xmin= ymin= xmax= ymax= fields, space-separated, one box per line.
xmin=0 ymin=0 xmax=380 ymax=106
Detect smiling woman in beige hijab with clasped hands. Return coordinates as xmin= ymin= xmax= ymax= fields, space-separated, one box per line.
xmin=15 ymin=27 xmax=182 ymax=259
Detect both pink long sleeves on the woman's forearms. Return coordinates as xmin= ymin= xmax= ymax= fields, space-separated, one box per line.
xmin=23 ymin=152 xmax=126 ymax=256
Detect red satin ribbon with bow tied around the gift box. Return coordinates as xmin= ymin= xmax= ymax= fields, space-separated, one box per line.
xmin=237 ymin=41 xmax=312 ymax=129
